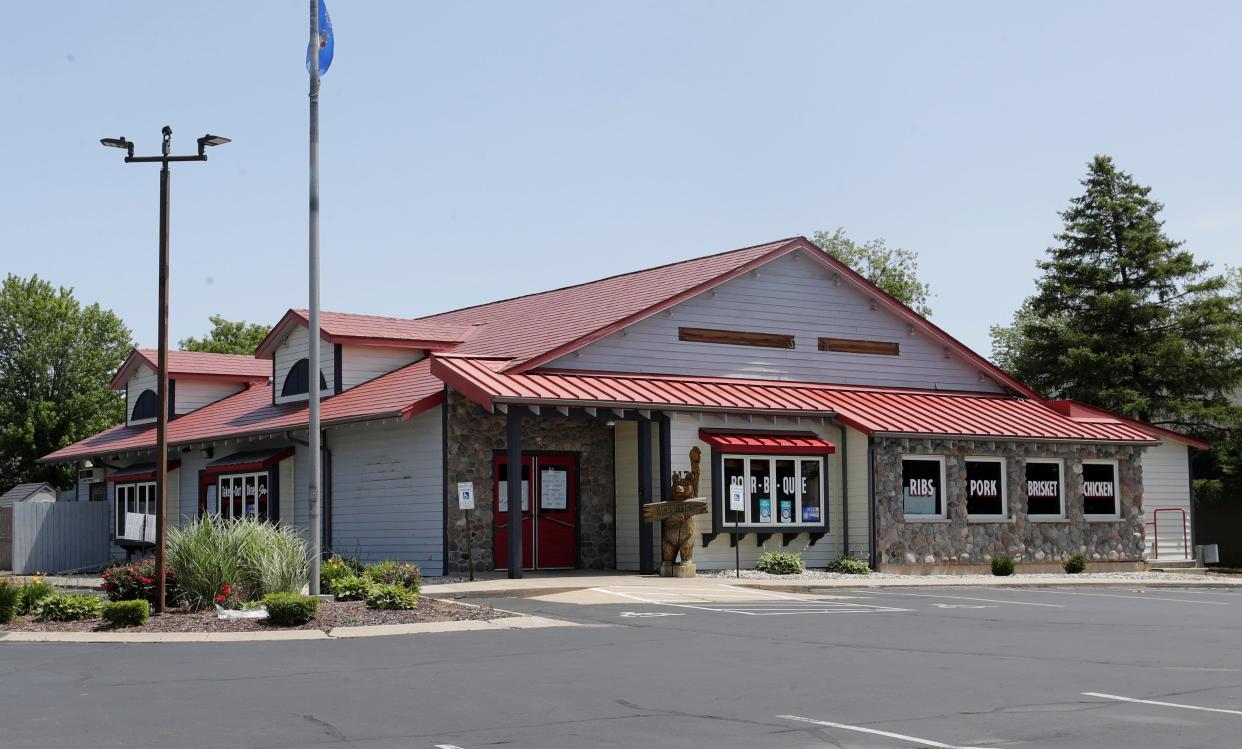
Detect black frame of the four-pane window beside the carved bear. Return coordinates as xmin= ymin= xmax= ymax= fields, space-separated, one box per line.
xmin=712 ymin=448 xmax=831 ymax=534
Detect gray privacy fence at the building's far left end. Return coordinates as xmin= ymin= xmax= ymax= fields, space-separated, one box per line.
xmin=9 ymin=502 xmax=109 ymax=575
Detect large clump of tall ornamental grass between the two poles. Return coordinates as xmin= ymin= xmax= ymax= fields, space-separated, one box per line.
xmin=168 ymin=517 xmax=311 ymax=611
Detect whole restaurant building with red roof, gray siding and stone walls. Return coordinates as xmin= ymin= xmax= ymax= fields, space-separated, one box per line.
xmin=43 ymin=237 xmax=1207 ymax=574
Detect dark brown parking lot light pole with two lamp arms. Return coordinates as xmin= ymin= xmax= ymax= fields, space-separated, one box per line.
xmin=99 ymin=125 xmax=229 ymax=614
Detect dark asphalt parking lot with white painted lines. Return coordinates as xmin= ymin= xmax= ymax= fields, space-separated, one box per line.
xmin=0 ymin=581 xmax=1242 ymax=749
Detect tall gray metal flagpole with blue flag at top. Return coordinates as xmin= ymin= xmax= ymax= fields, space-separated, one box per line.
xmin=307 ymin=0 xmax=325 ymax=595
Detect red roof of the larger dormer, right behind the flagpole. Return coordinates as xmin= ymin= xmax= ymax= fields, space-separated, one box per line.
xmin=255 ymin=309 xmax=473 ymax=359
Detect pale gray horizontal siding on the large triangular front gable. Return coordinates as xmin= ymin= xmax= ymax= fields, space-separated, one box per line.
xmin=548 ymin=255 xmax=1000 ymax=391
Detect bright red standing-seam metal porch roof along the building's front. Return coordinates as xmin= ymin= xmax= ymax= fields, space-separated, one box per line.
xmin=431 ymin=355 xmax=1154 ymax=443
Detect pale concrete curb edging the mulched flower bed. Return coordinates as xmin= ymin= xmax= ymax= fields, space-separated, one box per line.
xmin=0 ymin=611 xmax=581 ymax=645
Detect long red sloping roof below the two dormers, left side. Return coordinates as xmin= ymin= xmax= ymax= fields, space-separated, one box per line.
xmin=41 ymin=359 xmax=443 ymax=462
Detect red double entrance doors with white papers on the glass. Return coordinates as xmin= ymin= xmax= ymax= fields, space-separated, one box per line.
xmin=492 ymin=455 xmax=578 ymax=570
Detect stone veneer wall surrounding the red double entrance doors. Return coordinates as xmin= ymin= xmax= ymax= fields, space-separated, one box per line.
xmin=445 ymin=390 xmax=616 ymax=574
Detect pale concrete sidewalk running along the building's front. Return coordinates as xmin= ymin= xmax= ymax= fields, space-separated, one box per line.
xmin=422 ymin=570 xmax=1242 ymax=599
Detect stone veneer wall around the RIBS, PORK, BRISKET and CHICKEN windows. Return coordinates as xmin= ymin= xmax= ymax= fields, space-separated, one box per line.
xmin=874 ymin=437 xmax=1144 ymax=565
